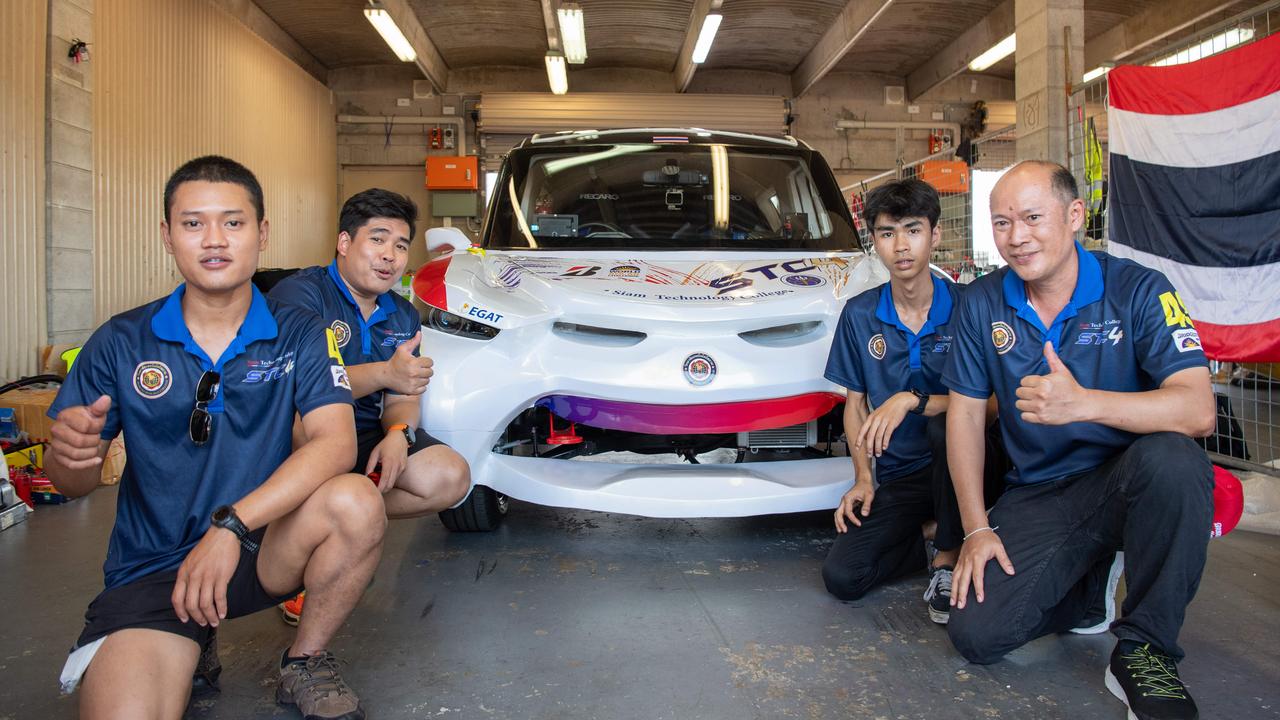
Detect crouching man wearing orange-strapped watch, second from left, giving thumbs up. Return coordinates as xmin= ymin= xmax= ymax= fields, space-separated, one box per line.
xmin=270 ymin=188 xmax=471 ymax=623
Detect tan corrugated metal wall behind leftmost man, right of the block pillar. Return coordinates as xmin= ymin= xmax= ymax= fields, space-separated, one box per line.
xmin=93 ymin=0 xmax=338 ymax=322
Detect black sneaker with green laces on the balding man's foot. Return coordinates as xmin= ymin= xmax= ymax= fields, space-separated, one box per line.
xmin=1107 ymin=639 xmax=1199 ymax=720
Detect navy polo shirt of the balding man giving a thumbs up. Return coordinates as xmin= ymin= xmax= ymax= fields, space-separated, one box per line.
xmin=943 ymin=243 xmax=1207 ymax=484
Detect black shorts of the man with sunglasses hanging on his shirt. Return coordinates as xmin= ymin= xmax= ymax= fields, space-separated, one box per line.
xmin=76 ymin=528 xmax=302 ymax=648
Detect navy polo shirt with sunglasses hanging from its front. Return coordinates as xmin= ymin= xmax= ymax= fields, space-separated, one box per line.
xmin=49 ymin=284 xmax=351 ymax=588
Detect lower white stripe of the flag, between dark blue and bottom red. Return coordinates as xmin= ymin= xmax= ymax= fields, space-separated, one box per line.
xmin=1107 ymin=241 xmax=1280 ymax=325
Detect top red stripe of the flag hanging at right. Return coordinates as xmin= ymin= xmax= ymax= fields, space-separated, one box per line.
xmin=1107 ymin=33 xmax=1280 ymax=115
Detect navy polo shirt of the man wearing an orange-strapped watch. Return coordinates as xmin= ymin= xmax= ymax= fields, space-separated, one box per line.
xmin=271 ymin=260 xmax=422 ymax=430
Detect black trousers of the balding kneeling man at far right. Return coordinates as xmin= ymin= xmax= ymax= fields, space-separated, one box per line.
xmin=947 ymin=433 xmax=1213 ymax=662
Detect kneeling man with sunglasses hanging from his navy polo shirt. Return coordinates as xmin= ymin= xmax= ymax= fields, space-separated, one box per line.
xmin=46 ymin=156 xmax=385 ymax=720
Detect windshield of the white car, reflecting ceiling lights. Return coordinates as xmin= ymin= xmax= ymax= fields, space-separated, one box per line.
xmin=485 ymin=143 xmax=856 ymax=251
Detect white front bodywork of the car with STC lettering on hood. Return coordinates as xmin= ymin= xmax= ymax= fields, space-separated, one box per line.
xmin=422 ymin=249 xmax=888 ymax=518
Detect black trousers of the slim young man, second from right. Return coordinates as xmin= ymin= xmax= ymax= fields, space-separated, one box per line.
xmin=822 ymin=413 xmax=1007 ymax=600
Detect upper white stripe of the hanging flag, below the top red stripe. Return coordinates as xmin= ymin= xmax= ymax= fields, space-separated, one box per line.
xmin=1107 ymin=92 xmax=1280 ymax=168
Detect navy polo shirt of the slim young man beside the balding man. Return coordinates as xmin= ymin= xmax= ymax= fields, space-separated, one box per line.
xmin=826 ymin=278 xmax=959 ymax=483
